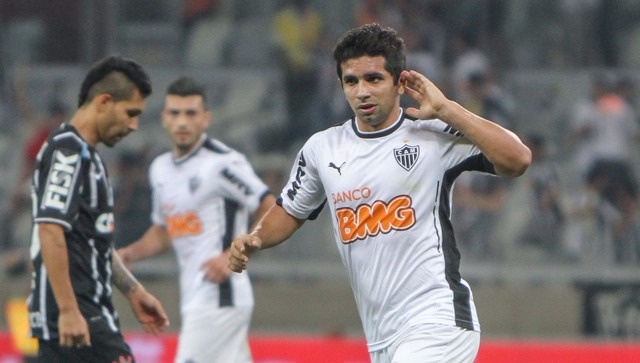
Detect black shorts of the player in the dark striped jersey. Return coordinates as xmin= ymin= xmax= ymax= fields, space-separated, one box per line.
xmin=37 ymin=332 xmax=136 ymax=363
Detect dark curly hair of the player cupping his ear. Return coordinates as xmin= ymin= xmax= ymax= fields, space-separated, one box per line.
xmin=333 ymin=23 xmax=406 ymax=84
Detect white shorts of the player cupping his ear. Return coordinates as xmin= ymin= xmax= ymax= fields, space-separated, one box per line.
xmin=370 ymin=324 xmax=480 ymax=363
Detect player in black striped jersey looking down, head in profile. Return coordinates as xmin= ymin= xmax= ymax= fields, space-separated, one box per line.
xmin=29 ymin=56 xmax=168 ymax=362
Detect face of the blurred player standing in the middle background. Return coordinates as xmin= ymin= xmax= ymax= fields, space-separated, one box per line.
xmin=162 ymin=95 xmax=211 ymax=155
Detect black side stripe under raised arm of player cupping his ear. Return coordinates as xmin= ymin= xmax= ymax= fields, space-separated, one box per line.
xmin=439 ymin=154 xmax=495 ymax=330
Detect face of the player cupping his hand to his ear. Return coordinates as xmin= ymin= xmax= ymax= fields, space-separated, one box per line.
xmin=341 ymin=56 xmax=403 ymax=131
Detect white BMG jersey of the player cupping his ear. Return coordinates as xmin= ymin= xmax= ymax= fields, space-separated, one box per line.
xmin=278 ymin=110 xmax=495 ymax=351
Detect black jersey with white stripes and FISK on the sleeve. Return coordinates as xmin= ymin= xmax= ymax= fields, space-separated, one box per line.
xmin=29 ymin=124 xmax=119 ymax=340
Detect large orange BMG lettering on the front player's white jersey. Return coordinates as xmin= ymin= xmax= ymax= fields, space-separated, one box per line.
xmin=336 ymin=195 xmax=416 ymax=244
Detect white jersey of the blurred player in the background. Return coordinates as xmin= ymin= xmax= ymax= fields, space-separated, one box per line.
xmin=149 ymin=135 xmax=270 ymax=314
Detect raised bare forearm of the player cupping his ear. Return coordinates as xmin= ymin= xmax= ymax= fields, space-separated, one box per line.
xmin=438 ymin=101 xmax=531 ymax=176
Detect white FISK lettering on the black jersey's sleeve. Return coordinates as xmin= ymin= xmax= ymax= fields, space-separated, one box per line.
xmin=43 ymin=151 xmax=80 ymax=211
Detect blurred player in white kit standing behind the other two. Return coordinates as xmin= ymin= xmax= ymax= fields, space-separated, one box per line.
xmin=118 ymin=77 xmax=275 ymax=363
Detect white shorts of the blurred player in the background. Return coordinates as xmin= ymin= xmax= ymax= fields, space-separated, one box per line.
xmin=175 ymin=307 xmax=253 ymax=363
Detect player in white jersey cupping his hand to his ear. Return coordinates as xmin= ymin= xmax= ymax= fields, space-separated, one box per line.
xmin=230 ymin=24 xmax=531 ymax=363
